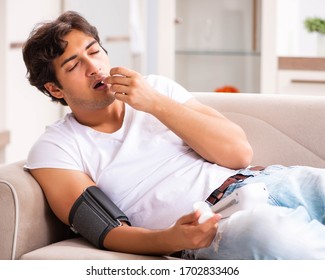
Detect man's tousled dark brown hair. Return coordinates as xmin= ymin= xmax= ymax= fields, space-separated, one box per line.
xmin=23 ymin=11 xmax=100 ymax=105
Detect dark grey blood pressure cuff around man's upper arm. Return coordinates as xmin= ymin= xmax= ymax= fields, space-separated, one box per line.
xmin=69 ymin=186 xmax=131 ymax=249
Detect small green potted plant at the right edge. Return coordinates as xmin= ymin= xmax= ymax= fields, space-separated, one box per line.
xmin=304 ymin=17 xmax=325 ymax=56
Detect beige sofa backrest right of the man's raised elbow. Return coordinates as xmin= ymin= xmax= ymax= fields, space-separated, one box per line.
xmin=194 ymin=92 xmax=325 ymax=168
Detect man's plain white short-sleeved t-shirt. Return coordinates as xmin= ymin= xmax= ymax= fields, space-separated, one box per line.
xmin=26 ymin=75 xmax=236 ymax=229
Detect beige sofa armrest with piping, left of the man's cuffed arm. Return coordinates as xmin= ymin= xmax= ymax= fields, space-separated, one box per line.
xmin=0 ymin=161 xmax=69 ymax=259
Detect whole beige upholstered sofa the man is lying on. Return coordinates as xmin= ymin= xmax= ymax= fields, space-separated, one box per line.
xmin=0 ymin=93 xmax=325 ymax=259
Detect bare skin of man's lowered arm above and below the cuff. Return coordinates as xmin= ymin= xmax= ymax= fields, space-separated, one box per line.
xmin=31 ymin=168 xmax=220 ymax=255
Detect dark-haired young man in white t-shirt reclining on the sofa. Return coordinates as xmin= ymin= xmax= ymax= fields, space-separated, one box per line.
xmin=23 ymin=12 xmax=325 ymax=259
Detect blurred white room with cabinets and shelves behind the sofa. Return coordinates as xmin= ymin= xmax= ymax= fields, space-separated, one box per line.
xmin=0 ymin=0 xmax=325 ymax=163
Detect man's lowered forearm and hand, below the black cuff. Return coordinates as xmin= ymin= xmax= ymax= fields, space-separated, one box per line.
xmin=104 ymin=211 xmax=221 ymax=255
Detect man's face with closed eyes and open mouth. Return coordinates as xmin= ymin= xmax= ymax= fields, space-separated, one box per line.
xmin=51 ymin=30 xmax=115 ymax=110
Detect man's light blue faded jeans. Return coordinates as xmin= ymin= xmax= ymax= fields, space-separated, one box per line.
xmin=183 ymin=165 xmax=325 ymax=260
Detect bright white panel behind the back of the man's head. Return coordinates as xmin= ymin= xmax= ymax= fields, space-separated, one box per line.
xmin=0 ymin=0 xmax=61 ymax=162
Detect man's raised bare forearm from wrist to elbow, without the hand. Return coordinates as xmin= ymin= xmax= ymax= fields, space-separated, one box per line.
xmin=151 ymin=95 xmax=252 ymax=169
